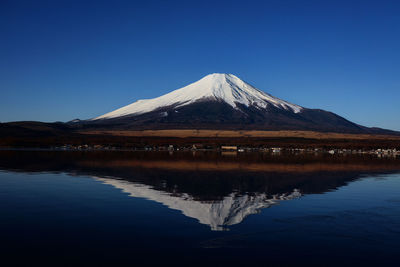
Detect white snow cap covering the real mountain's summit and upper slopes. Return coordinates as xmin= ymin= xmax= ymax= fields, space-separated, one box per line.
xmin=94 ymin=73 xmax=303 ymax=120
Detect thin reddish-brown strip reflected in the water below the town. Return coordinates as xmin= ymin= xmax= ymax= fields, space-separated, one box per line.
xmin=80 ymin=159 xmax=400 ymax=172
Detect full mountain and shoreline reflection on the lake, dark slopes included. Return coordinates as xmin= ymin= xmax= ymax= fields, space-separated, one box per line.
xmin=0 ymin=151 xmax=400 ymax=230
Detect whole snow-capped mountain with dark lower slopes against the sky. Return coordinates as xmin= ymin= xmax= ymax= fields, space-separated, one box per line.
xmin=85 ymin=73 xmax=393 ymax=134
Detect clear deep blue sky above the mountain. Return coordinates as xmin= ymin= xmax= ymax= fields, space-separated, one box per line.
xmin=0 ymin=0 xmax=400 ymax=130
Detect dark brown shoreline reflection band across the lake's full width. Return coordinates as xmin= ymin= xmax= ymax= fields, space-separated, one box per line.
xmin=0 ymin=151 xmax=400 ymax=173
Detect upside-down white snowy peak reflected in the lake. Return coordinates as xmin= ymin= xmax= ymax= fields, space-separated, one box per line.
xmin=95 ymin=178 xmax=301 ymax=230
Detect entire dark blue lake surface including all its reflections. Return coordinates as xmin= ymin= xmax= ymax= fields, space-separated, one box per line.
xmin=0 ymin=151 xmax=400 ymax=266
